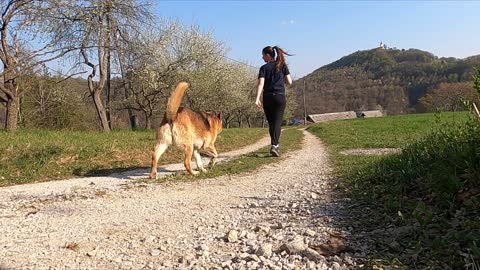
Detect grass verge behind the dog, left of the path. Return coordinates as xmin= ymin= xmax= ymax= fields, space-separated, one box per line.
xmin=0 ymin=126 xmax=268 ymax=186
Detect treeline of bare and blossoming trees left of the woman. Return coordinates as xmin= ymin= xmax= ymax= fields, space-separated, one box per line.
xmin=0 ymin=0 xmax=295 ymax=131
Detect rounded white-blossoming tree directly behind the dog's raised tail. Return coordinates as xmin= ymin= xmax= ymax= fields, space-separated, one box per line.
xmin=122 ymin=21 xmax=224 ymax=128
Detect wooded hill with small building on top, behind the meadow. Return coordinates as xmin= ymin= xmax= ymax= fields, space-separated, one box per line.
xmin=293 ymin=48 xmax=480 ymax=116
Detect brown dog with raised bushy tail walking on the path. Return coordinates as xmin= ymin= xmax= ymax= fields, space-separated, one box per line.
xmin=150 ymin=82 xmax=222 ymax=179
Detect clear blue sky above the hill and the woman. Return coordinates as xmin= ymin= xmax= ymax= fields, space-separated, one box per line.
xmin=155 ymin=0 xmax=480 ymax=77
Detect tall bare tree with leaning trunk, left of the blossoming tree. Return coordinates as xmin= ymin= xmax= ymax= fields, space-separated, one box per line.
xmin=62 ymin=0 xmax=153 ymax=131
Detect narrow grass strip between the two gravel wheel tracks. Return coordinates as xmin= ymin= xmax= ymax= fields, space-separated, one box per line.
xmin=158 ymin=128 xmax=303 ymax=182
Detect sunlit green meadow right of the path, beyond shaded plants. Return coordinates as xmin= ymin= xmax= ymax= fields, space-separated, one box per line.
xmin=308 ymin=113 xmax=468 ymax=184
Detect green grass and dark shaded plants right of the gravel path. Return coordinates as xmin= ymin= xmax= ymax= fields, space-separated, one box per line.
xmin=309 ymin=113 xmax=480 ymax=269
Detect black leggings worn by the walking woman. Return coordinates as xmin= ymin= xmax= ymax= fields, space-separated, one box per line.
xmin=263 ymin=94 xmax=287 ymax=145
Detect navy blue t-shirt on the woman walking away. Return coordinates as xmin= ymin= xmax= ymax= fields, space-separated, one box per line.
xmin=258 ymin=61 xmax=290 ymax=94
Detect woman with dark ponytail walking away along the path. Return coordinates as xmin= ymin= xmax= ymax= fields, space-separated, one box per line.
xmin=255 ymin=46 xmax=292 ymax=157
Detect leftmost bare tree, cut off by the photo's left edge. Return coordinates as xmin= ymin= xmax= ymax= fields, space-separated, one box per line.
xmin=0 ymin=0 xmax=79 ymax=131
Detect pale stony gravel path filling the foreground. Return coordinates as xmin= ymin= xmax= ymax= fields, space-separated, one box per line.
xmin=0 ymin=132 xmax=367 ymax=270
